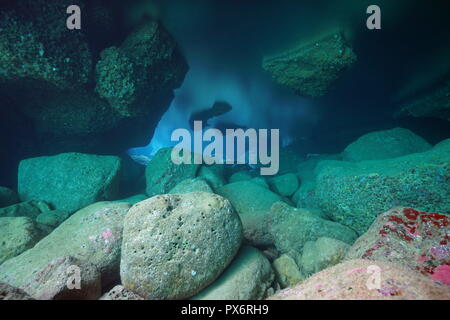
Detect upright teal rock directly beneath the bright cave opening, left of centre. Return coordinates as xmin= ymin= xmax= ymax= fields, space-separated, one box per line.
xmin=145 ymin=148 xmax=199 ymax=197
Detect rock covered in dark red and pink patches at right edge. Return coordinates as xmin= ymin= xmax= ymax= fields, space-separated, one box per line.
xmin=346 ymin=207 xmax=450 ymax=285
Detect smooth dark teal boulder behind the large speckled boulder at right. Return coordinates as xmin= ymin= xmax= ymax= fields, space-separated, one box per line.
xmin=342 ymin=128 xmax=432 ymax=161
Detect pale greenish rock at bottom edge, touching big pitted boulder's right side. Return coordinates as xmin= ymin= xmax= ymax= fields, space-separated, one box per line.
xmin=191 ymin=246 xmax=275 ymax=300
